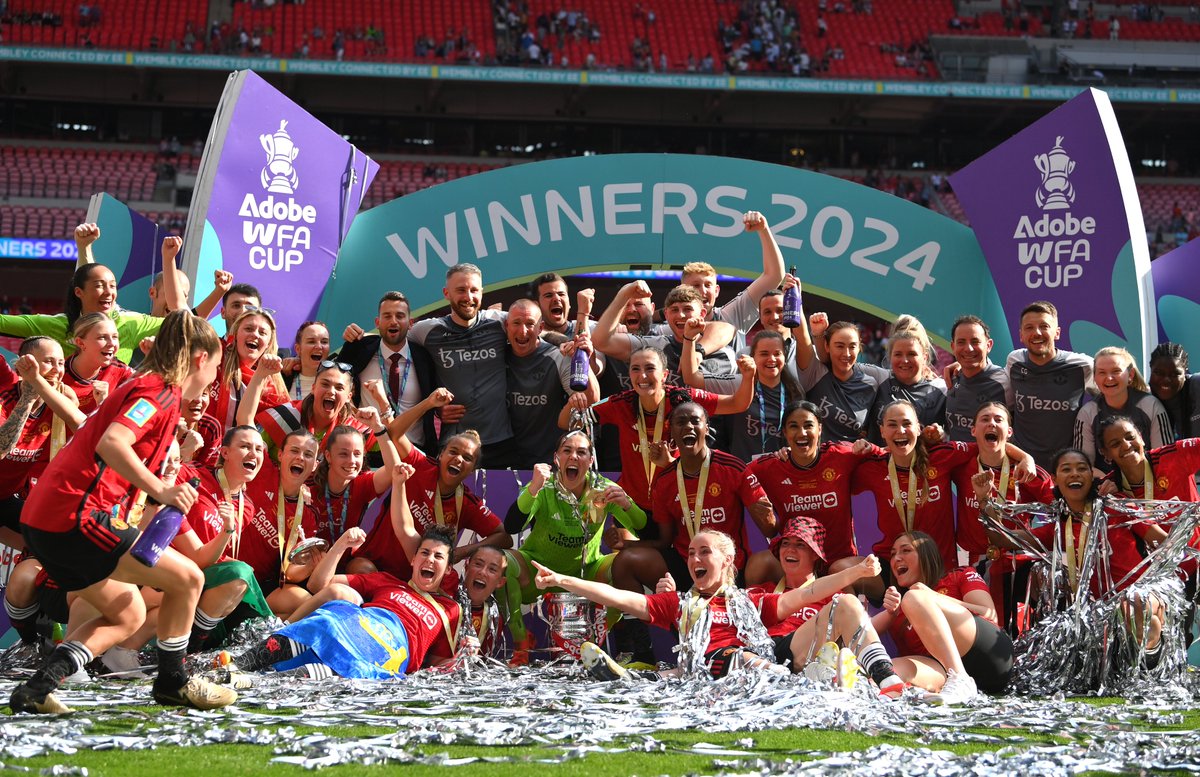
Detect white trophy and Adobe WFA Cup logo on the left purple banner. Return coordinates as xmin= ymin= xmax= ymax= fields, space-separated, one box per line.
xmin=238 ymin=120 xmax=317 ymax=272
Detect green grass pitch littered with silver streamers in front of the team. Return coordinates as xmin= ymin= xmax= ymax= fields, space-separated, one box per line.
xmin=0 ymin=671 xmax=1200 ymax=777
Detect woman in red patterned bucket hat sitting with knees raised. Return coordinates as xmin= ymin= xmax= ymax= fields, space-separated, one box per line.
xmin=749 ymin=516 xmax=905 ymax=699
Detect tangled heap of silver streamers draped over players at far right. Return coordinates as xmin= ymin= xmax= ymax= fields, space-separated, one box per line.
xmin=980 ymin=499 xmax=1200 ymax=700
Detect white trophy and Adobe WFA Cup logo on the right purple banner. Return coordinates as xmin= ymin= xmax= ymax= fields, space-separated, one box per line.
xmin=1013 ymin=135 xmax=1096 ymax=289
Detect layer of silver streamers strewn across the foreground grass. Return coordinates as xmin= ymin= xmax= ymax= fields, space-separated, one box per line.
xmin=0 ymin=647 xmax=1200 ymax=777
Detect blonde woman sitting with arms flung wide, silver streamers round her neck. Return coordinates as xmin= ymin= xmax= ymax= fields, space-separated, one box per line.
xmin=534 ymin=529 xmax=878 ymax=680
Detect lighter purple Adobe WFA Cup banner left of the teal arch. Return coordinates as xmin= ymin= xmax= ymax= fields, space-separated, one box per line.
xmin=184 ymin=71 xmax=379 ymax=343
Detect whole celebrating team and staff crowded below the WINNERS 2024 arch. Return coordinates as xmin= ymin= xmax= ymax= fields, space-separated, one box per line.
xmin=0 ymin=211 xmax=1185 ymax=712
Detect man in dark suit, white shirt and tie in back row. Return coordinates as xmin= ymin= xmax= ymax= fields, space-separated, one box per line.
xmin=334 ymin=291 xmax=438 ymax=453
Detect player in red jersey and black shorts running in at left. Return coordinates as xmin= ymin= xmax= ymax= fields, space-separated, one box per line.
xmin=10 ymin=311 xmax=238 ymax=712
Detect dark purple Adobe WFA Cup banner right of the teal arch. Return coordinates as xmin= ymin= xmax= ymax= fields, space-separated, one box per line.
xmin=950 ymin=89 xmax=1156 ymax=362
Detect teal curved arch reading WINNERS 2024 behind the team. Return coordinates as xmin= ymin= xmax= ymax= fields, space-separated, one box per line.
xmin=319 ymin=153 xmax=1012 ymax=354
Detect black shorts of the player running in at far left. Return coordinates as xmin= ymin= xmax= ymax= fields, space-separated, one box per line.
xmin=20 ymin=510 xmax=138 ymax=591
